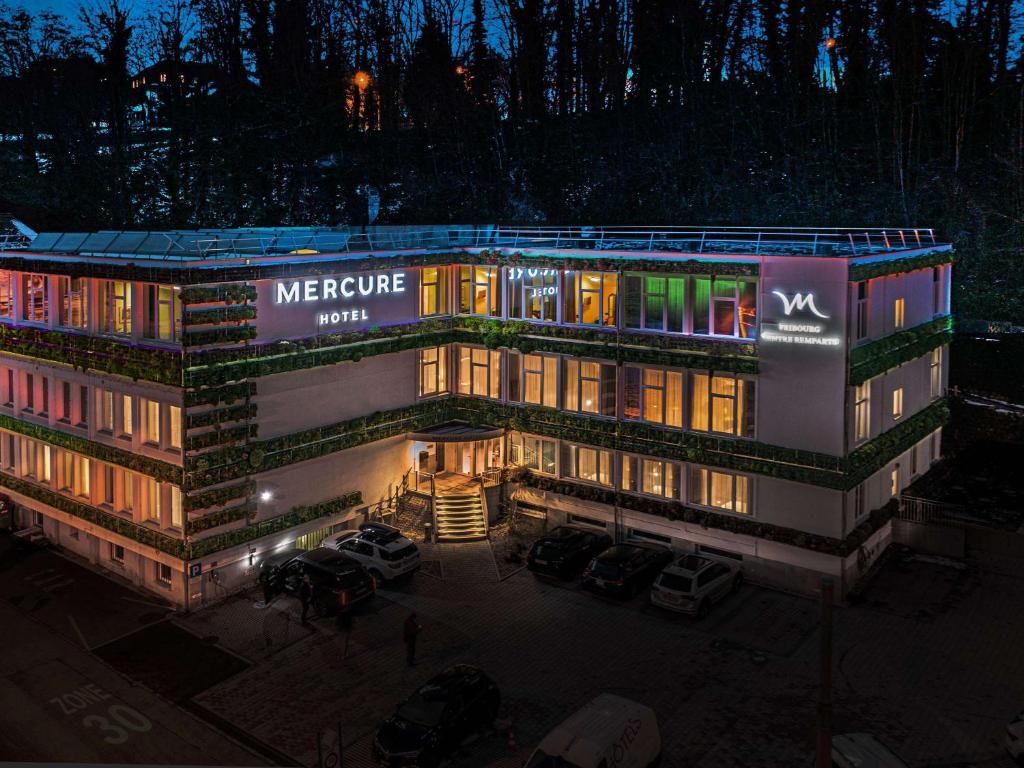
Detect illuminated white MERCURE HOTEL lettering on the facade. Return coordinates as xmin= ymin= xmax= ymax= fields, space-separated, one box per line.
xmin=273 ymin=272 xmax=406 ymax=326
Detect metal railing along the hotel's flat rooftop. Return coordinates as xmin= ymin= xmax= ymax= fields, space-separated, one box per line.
xmin=16 ymin=225 xmax=939 ymax=261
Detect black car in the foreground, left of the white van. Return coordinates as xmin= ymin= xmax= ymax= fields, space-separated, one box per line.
xmin=374 ymin=665 xmax=501 ymax=768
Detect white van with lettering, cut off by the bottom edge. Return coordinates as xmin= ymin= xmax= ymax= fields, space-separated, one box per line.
xmin=526 ymin=693 xmax=662 ymax=768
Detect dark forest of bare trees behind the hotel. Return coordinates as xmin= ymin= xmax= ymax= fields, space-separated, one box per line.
xmin=0 ymin=0 xmax=1024 ymax=324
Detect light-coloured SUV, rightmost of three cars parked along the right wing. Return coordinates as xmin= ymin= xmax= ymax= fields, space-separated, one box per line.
xmin=650 ymin=555 xmax=743 ymax=617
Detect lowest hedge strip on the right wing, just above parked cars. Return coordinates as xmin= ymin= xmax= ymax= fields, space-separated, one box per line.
xmin=520 ymin=472 xmax=897 ymax=557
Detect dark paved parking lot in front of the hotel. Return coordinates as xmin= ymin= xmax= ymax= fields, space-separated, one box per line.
xmin=6 ymin=536 xmax=1024 ymax=768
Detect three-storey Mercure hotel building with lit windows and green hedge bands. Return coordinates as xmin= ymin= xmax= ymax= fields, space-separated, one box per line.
xmin=0 ymin=226 xmax=952 ymax=609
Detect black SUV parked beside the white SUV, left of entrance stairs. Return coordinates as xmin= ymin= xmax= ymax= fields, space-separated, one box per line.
xmin=260 ymin=547 xmax=374 ymax=616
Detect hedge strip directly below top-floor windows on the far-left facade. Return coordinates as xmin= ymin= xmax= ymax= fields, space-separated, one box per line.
xmin=0 ymin=323 xmax=182 ymax=386
